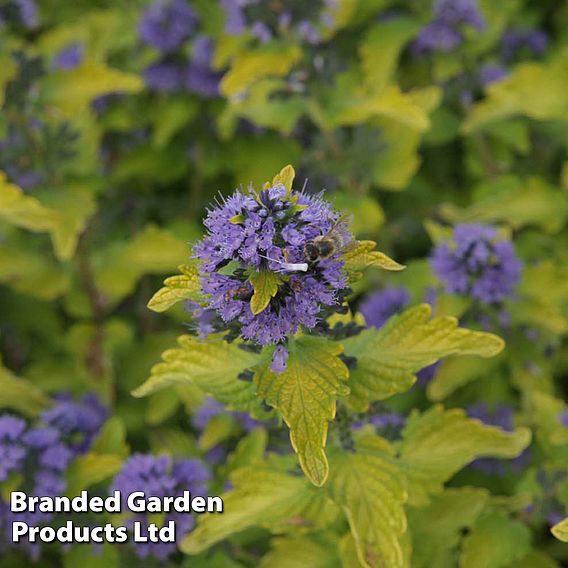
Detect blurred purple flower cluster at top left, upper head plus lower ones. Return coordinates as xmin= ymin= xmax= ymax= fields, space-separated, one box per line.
xmin=138 ymin=0 xmax=221 ymax=98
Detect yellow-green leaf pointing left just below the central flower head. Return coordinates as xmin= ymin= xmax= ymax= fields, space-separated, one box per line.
xmin=133 ymin=335 xmax=260 ymax=411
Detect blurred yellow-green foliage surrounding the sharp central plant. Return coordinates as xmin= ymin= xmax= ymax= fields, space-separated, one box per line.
xmin=0 ymin=0 xmax=568 ymax=567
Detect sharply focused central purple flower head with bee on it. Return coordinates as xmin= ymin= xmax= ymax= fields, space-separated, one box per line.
xmin=194 ymin=184 xmax=352 ymax=345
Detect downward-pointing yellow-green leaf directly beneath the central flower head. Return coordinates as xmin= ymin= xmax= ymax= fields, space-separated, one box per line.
xmin=254 ymin=337 xmax=349 ymax=485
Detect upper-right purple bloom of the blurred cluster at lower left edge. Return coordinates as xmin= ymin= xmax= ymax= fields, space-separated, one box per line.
xmin=42 ymin=393 xmax=109 ymax=453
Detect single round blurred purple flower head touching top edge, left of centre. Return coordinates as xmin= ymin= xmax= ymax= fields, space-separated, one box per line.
xmin=138 ymin=0 xmax=198 ymax=53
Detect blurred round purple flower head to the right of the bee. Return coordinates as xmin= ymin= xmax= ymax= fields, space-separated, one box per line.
xmin=430 ymin=224 xmax=522 ymax=304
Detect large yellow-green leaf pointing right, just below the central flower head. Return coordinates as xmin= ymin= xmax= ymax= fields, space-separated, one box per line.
xmin=343 ymin=304 xmax=504 ymax=410
